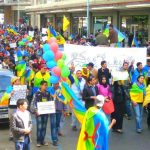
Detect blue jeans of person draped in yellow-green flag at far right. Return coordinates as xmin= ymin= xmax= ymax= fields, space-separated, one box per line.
xmin=133 ymin=104 xmax=143 ymax=130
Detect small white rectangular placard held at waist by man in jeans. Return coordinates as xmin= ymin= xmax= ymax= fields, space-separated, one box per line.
xmin=37 ymin=101 xmax=56 ymax=115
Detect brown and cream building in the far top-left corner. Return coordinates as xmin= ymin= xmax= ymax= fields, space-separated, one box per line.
xmin=0 ymin=0 xmax=31 ymax=24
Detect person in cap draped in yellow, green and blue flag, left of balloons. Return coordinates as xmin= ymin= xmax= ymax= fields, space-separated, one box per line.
xmin=33 ymin=64 xmax=51 ymax=93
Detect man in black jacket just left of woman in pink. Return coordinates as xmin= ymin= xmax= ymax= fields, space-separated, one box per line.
xmin=82 ymin=76 xmax=98 ymax=109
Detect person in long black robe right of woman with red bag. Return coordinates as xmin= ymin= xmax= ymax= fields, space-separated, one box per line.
xmin=111 ymin=81 xmax=125 ymax=133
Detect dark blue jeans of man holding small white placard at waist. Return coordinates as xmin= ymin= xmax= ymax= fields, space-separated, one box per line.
xmin=36 ymin=115 xmax=48 ymax=144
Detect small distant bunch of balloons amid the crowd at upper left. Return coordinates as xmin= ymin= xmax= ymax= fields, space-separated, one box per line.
xmin=18 ymin=34 xmax=33 ymax=47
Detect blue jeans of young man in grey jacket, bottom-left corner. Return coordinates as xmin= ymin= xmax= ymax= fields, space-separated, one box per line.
xmin=15 ymin=135 xmax=30 ymax=150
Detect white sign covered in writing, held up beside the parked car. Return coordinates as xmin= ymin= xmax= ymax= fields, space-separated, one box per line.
xmin=10 ymin=85 xmax=27 ymax=105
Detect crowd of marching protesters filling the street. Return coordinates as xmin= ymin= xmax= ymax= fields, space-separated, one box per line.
xmin=0 ymin=22 xmax=150 ymax=150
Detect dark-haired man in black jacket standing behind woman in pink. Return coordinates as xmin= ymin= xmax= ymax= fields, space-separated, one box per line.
xmin=98 ymin=61 xmax=111 ymax=84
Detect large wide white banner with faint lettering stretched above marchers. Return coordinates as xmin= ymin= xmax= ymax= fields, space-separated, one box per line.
xmin=64 ymin=44 xmax=147 ymax=70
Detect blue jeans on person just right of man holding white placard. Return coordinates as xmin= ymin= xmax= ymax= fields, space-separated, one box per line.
xmin=50 ymin=110 xmax=62 ymax=142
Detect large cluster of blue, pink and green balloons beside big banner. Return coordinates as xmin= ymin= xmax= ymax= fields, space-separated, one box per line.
xmin=43 ymin=37 xmax=70 ymax=84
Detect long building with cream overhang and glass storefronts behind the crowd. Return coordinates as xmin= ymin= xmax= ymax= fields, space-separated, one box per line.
xmin=26 ymin=0 xmax=150 ymax=39
